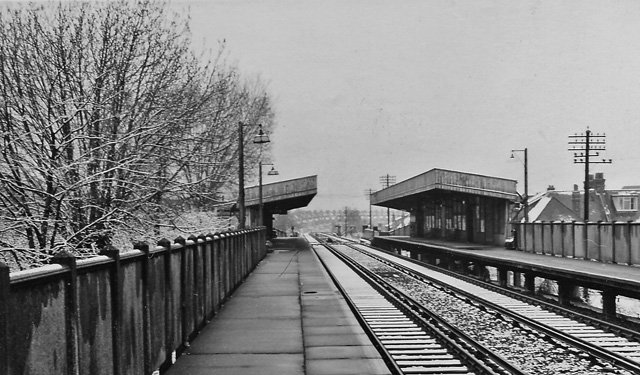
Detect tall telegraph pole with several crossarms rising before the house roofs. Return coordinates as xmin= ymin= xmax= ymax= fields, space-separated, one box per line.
xmin=569 ymin=127 xmax=611 ymax=222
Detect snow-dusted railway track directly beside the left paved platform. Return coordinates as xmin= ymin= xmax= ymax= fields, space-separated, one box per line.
xmin=310 ymin=234 xmax=525 ymax=375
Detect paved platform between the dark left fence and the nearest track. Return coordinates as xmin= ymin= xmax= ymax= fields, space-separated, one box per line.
xmin=167 ymin=238 xmax=389 ymax=375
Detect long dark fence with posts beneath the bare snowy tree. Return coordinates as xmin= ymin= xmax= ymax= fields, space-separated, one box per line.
xmin=0 ymin=228 xmax=266 ymax=375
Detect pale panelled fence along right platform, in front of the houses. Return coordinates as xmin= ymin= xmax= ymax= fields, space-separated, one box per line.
xmin=513 ymin=221 xmax=640 ymax=265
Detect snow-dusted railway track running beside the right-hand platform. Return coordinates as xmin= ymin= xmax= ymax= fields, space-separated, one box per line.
xmin=318 ymin=235 xmax=640 ymax=374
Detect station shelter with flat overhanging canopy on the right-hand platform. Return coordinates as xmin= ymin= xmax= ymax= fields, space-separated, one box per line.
xmin=371 ymin=168 xmax=518 ymax=246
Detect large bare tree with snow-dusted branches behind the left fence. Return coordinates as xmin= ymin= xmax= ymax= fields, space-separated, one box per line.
xmin=0 ymin=0 xmax=273 ymax=270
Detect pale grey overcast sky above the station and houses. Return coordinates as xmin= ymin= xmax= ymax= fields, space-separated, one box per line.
xmin=7 ymin=0 xmax=640 ymax=209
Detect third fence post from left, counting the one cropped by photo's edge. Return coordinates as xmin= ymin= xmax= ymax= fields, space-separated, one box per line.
xmin=100 ymin=246 xmax=124 ymax=375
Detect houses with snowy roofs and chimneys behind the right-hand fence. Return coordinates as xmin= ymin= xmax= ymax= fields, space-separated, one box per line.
xmin=516 ymin=173 xmax=640 ymax=222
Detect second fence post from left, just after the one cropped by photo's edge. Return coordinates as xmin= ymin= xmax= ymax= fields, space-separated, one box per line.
xmin=51 ymin=250 xmax=80 ymax=375
